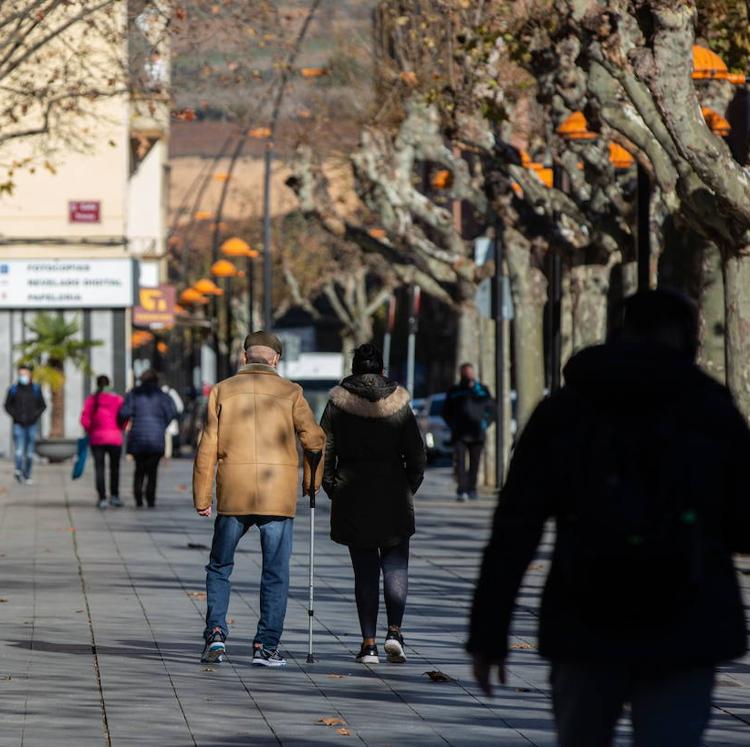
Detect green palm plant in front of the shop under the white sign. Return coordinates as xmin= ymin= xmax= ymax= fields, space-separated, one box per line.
xmin=16 ymin=312 xmax=102 ymax=438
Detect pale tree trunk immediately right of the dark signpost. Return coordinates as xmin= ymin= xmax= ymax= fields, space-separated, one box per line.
xmin=505 ymin=231 xmax=547 ymax=433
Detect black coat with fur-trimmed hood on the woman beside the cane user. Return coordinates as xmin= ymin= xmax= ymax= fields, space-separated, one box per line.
xmin=320 ymin=374 xmax=426 ymax=548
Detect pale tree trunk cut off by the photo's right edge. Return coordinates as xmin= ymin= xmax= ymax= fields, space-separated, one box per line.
xmin=723 ymin=247 xmax=750 ymax=420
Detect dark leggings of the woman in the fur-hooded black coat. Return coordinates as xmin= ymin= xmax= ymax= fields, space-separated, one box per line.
xmin=349 ymin=539 xmax=409 ymax=638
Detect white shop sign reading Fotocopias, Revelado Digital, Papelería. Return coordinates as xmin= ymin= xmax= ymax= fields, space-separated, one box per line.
xmin=0 ymin=259 xmax=138 ymax=309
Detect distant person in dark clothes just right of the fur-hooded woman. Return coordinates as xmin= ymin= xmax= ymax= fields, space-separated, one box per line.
xmin=443 ymin=363 xmax=494 ymax=502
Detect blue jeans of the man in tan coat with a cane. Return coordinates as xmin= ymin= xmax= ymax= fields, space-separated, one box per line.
xmin=204 ymin=514 xmax=294 ymax=649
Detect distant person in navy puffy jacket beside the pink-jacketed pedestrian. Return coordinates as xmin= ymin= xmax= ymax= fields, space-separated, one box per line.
xmin=120 ymin=369 xmax=177 ymax=508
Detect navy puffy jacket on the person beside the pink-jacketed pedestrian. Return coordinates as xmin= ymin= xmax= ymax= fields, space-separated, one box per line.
xmin=120 ymin=384 xmax=177 ymax=455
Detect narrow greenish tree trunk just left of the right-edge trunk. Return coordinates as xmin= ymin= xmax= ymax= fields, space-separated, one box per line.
xmin=698 ymin=241 xmax=726 ymax=384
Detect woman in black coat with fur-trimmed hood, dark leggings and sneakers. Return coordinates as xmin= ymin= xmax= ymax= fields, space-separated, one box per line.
xmin=321 ymin=345 xmax=426 ymax=664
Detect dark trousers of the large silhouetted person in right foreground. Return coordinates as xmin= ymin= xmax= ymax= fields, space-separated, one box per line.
xmin=550 ymin=657 xmax=714 ymax=747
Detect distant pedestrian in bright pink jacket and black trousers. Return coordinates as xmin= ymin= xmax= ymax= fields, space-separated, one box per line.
xmin=81 ymin=376 xmax=124 ymax=509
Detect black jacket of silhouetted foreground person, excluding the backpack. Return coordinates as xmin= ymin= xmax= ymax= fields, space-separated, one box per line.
xmin=467 ymin=345 xmax=750 ymax=665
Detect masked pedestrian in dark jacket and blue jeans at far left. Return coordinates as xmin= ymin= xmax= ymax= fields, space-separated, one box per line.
xmin=5 ymin=364 xmax=47 ymax=485
